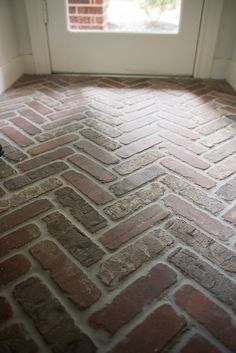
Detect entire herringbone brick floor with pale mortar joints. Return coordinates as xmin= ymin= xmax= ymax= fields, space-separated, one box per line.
xmin=0 ymin=75 xmax=236 ymax=353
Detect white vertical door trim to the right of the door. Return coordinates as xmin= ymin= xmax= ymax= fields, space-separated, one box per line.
xmin=193 ymin=0 xmax=224 ymax=78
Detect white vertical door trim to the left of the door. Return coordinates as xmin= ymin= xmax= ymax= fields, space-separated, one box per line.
xmin=25 ymin=0 xmax=51 ymax=74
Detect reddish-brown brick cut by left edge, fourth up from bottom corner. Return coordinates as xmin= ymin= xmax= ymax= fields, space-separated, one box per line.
xmin=0 ymin=224 xmax=40 ymax=256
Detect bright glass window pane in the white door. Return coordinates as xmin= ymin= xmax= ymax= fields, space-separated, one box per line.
xmin=67 ymin=0 xmax=181 ymax=33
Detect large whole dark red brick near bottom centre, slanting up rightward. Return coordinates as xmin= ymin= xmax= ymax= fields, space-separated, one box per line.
xmin=89 ymin=264 xmax=176 ymax=335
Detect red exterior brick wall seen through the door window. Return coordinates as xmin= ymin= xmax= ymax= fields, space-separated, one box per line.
xmin=68 ymin=0 xmax=108 ymax=30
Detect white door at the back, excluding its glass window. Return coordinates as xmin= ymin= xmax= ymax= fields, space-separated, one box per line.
xmin=47 ymin=0 xmax=203 ymax=75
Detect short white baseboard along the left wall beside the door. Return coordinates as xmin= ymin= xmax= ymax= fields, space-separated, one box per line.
xmin=0 ymin=56 xmax=24 ymax=93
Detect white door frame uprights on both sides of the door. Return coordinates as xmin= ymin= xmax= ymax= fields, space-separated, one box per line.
xmin=25 ymin=0 xmax=224 ymax=78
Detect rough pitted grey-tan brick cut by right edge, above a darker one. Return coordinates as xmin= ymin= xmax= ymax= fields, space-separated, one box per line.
xmin=169 ymin=220 xmax=236 ymax=273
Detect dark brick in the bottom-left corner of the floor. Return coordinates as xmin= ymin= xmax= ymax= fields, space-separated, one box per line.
xmin=0 ymin=324 xmax=38 ymax=353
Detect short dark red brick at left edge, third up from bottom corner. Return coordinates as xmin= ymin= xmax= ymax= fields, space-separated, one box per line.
xmin=0 ymin=254 xmax=31 ymax=286
